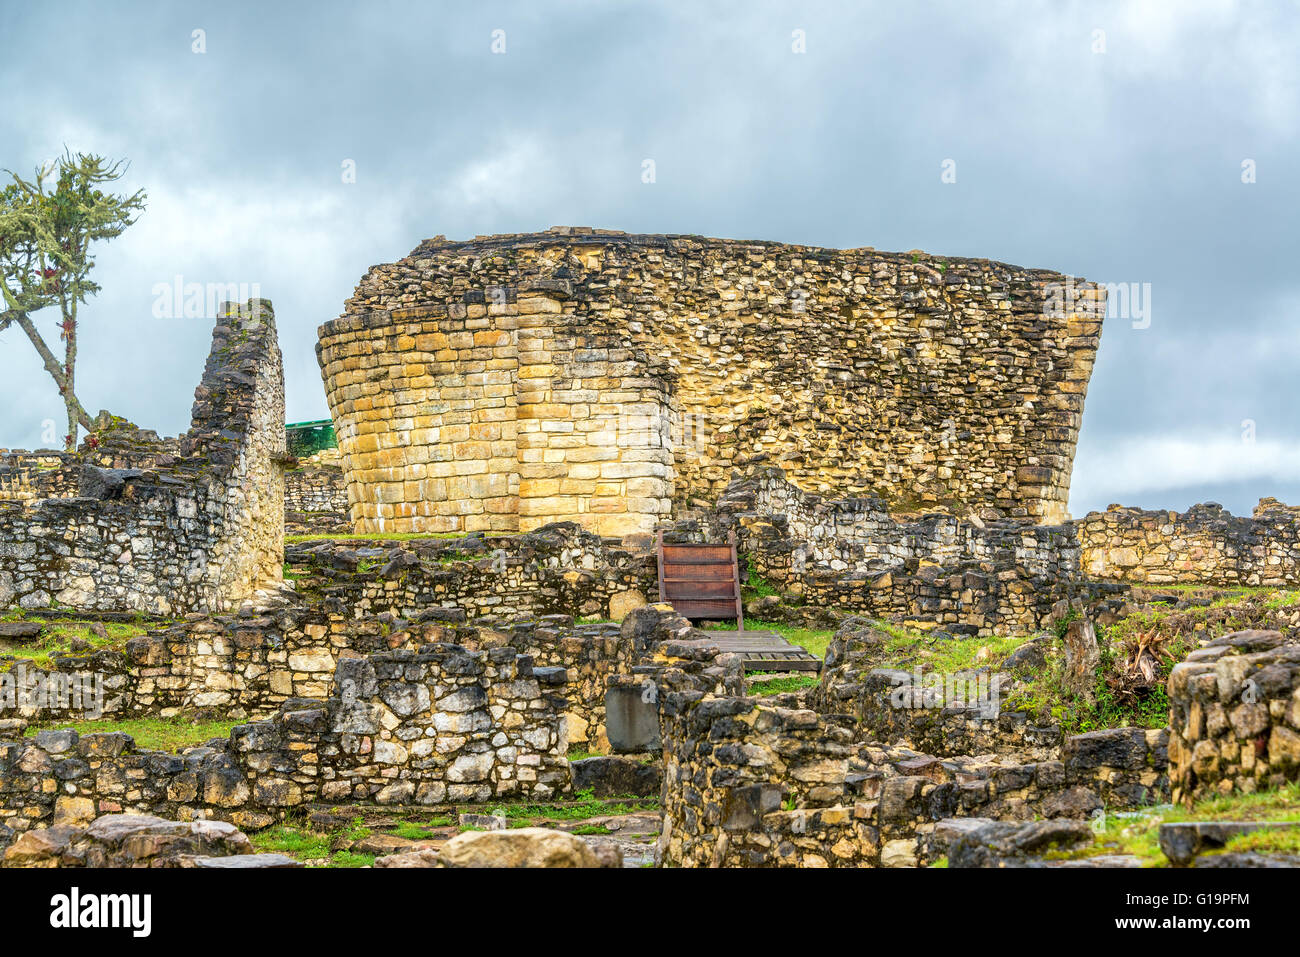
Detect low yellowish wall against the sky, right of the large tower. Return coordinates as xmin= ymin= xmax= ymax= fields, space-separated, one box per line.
xmin=1074 ymin=498 xmax=1300 ymax=586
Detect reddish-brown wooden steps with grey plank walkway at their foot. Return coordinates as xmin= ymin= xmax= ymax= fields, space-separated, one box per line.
xmin=655 ymin=529 xmax=822 ymax=671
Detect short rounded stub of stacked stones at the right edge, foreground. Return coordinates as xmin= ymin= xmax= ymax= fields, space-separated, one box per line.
xmin=1169 ymin=631 xmax=1300 ymax=805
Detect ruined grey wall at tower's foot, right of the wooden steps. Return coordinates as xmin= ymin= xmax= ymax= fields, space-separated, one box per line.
xmin=691 ymin=465 xmax=1122 ymax=635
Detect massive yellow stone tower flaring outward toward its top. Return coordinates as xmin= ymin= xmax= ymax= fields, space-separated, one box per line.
xmin=317 ymin=228 xmax=1105 ymax=534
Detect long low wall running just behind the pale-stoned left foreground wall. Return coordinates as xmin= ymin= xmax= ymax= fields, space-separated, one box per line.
xmin=0 ymin=607 xmax=645 ymax=752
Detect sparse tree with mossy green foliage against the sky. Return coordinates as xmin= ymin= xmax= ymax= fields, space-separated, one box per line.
xmin=0 ymin=152 xmax=146 ymax=449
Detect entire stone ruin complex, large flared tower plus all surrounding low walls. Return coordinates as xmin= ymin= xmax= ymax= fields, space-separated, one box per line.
xmin=0 ymin=230 xmax=1300 ymax=867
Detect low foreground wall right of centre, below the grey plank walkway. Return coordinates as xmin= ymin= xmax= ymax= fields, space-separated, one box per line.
xmin=659 ymin=693 xmax=1167 ymax=867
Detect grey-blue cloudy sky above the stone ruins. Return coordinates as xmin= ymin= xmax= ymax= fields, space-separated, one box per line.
xmin=0 ymin=0 xmax=1300 ymax=515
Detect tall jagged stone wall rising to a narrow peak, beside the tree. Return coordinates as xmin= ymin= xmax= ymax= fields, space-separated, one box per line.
xmin=0 ymin=300 xmax=285 ymax=614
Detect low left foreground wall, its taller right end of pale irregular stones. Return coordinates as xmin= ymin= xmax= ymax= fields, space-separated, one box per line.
xmin=0 ymin=644 xmax=571 ymax=831
